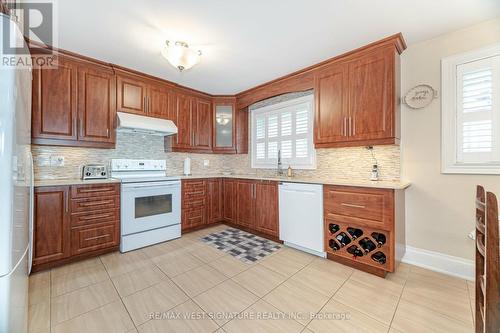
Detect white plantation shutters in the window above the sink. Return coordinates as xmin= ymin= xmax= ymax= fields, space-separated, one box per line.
xmin=251 ymin=95 xmax=316 ymax=169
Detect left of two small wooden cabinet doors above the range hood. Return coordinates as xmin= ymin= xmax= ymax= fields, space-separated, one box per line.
xmin=117 ymin=75 xmax=147 ymax=116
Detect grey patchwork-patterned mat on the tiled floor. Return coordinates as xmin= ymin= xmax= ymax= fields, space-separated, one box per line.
xmin=200 ymin=228 xmax=281 ymax=263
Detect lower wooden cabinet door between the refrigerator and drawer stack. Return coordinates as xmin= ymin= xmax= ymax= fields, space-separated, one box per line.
xmin=33 ymin=186 xmax=71 ymax=266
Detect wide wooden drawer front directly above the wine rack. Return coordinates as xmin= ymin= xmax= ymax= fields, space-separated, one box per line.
xmin=323 ymin=186 xmax=394 ymax=224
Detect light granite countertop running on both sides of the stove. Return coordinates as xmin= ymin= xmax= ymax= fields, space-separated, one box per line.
xmin=35 ymin=174 xmax=410 ymax=190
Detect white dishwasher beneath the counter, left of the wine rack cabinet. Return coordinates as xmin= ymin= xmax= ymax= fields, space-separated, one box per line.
xmin=279 ymin=182 xmax=326 ymax=257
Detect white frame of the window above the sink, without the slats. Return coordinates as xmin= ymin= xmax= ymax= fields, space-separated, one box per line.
xmin=250 ymin=94 xmax=317 ymax=170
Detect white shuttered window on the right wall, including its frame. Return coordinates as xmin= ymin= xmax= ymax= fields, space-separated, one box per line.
xmin=443 ymin=46 xmax=500 ymax=174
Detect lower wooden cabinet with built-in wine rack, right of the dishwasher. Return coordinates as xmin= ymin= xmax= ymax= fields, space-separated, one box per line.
xmin=323 ymin=186 xmax=405 ymax=276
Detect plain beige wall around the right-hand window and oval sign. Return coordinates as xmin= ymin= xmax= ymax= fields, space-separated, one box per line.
xmin=402 ymin=17 xmax=500 ymax=260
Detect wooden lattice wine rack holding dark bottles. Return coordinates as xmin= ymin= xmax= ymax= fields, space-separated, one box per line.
xmin=325 ymin=219 xmax=393 ymax=271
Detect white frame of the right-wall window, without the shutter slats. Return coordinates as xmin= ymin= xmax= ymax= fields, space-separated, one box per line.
xmin=441 ymin=44 xmax=500 ymax=175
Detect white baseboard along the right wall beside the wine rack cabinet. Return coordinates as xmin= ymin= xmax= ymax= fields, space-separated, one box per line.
xmin=401 ymin=245 xmax=475 ymax=281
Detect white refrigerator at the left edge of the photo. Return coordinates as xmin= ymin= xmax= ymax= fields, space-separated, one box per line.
xmin=0 ymin=14 xmax=33 ymax=333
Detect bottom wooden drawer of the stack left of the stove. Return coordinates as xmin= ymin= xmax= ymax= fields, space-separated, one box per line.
xmin=71 ymin=225 xmax=119 ymax=255
